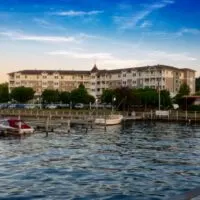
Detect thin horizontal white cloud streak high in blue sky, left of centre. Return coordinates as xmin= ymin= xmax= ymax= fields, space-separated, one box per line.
xmin=53 ymin=10 xmax=104 ymax=17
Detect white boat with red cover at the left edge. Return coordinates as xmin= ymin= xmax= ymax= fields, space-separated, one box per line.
xmin=0 ymin=119 xmax=34 ymax=135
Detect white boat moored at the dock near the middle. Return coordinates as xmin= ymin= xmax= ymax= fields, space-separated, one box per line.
xmin=94 ymin=114 xmax=123 ymax=125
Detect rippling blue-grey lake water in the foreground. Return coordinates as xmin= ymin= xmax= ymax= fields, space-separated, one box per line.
xmin=0 ymin=122 xmax=200 ymax=200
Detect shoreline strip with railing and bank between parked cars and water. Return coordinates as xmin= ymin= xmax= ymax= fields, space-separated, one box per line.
xmin=0 ymin=109 xmax=200 ymax=124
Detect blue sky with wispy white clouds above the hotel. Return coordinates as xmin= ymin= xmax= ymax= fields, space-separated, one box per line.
xmin=0 ymin=0 xmax=200 ymax=82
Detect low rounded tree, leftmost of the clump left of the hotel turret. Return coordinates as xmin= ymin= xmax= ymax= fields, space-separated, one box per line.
xmin=42 ymin=89 xmax=60 ymax=103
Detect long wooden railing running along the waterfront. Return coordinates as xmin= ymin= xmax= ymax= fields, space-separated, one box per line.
xmin=0 ymin=109 xmax=200 ymax=122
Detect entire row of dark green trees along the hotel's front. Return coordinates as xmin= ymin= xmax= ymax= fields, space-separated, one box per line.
xmin=0 ymin=83 xmax=197 ymax=110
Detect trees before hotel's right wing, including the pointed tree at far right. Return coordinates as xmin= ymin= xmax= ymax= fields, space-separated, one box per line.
xmin=101 ymin=83 xmax=193 ymax=110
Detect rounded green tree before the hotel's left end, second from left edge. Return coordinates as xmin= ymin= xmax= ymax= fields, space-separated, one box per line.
xmin=10 ymin=86 xmax=35 ymax=103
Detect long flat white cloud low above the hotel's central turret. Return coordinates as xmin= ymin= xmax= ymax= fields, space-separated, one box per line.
xmin=47 ymin=51 xmax=113 ymax=59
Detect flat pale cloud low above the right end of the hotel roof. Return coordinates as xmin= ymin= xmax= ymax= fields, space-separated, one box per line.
xmin=148 ymin=51 xmax=197 ymax=61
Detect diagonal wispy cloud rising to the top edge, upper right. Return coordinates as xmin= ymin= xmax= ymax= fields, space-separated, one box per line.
xmin=114 ymin=0 xmax=174 ymax=30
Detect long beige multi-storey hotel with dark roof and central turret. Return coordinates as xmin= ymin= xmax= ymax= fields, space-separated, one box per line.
xmin=8 ymin=65 xmax=195 ymax=98
